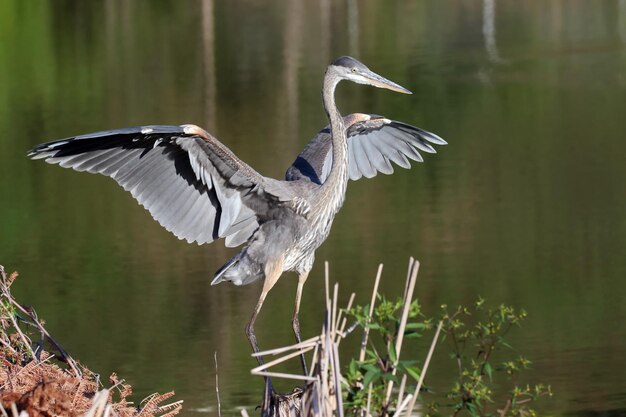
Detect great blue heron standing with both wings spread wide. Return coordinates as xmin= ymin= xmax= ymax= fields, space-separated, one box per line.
xmin=28 ymin=56 xmax=446 ymax=372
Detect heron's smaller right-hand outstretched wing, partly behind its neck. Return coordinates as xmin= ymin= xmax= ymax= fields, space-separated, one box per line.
xmin=285 ymin=113 xmax=446 ymax=184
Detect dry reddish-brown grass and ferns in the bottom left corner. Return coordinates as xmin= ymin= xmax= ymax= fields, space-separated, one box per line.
xmin=0 ymin=266 xmax=182 ymax=417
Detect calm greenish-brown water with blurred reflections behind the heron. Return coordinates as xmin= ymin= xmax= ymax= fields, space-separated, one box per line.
xmin=0 ymin=0 xmax=626 ymax=415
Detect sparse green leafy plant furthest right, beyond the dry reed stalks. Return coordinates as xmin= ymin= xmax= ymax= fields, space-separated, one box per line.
xmin=431 ymin=298 xmax=552 ymax=416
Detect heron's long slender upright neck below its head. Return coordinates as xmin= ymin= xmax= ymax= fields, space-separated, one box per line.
xmin=321 ymin=69 xmax=348 ymax=203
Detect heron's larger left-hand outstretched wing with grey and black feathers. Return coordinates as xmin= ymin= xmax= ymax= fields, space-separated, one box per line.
xmin=28 ymin=125 xmax=292 ymax=246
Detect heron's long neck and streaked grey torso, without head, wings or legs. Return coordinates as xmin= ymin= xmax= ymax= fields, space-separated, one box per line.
xmin=213 ymin=71 xmax=348 ymax=285
